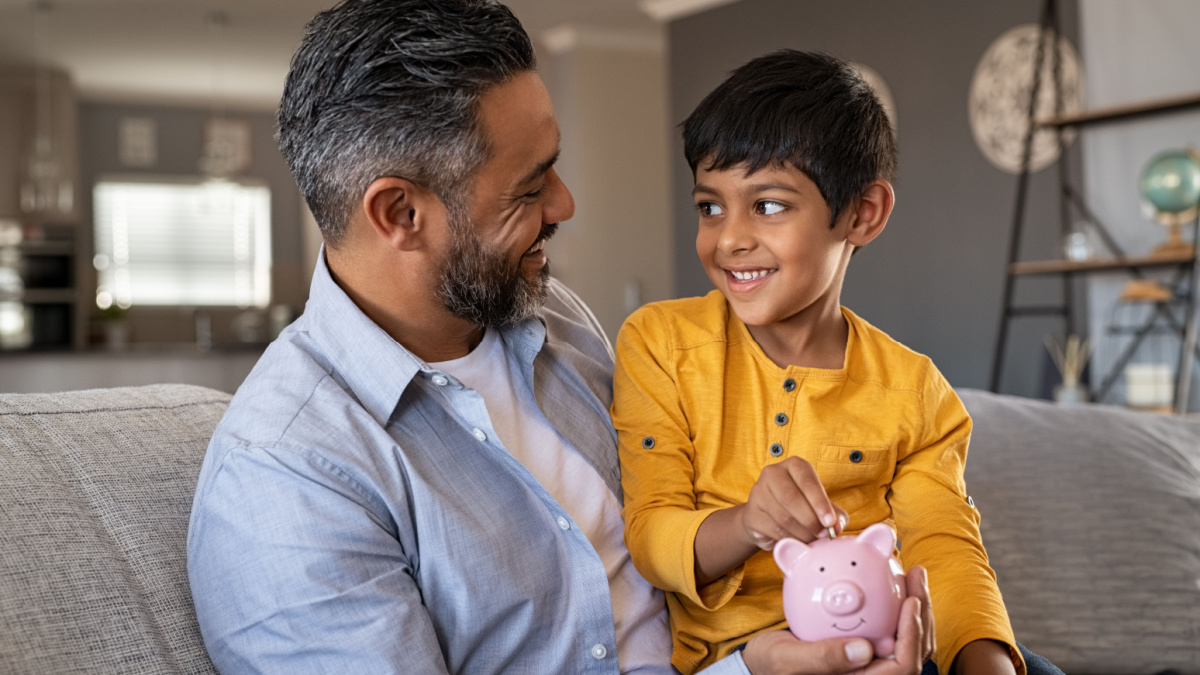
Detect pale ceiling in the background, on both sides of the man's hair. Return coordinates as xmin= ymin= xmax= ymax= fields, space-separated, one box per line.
xmin=0 ymin=0 xmax=667 ymax=109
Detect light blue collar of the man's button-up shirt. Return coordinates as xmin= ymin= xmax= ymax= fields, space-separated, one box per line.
xmin=305 ymin=245 xmax=546 ymax=426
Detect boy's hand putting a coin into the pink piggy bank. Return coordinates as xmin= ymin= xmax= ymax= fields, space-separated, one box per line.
xmin=738 ymin=458 xmax=848 ymax=551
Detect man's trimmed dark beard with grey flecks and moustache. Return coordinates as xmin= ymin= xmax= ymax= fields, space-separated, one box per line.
xmin=438 ymin=213 xmax=558 ymax=328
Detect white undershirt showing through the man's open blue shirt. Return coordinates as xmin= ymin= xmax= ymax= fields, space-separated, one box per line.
xmin=430 ymin=329 xmax=673 ymax=674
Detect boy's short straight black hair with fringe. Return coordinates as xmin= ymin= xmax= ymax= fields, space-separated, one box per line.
xmin=683 ymin=49 xmax=896 ymax=225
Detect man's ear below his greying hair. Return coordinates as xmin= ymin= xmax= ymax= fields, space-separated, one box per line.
xmin=362 ymin=175 xmax=445 ymax=251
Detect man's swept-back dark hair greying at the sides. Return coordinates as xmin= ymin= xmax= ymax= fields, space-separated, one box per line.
xmin=277 ymin=0 xmax=536 ymax=241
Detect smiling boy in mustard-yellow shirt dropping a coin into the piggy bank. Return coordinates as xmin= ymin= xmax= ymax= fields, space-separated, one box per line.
xmin=612 ymin=50 xmax=1025 ymax=674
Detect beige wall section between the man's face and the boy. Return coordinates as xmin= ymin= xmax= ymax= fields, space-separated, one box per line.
xmin=541 ymin=31 xmax=674 ymax=339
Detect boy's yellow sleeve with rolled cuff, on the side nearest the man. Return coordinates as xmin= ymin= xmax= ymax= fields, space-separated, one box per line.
xmin=612 ymin=306 xmax=744 ymax=610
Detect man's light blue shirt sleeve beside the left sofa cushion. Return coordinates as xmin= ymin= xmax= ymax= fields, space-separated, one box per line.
xmin=187 ymin=448 xmax=446 ymax=674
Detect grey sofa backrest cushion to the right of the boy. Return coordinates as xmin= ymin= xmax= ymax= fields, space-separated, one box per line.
xmin=960 ymin=390 xmax=1200 ymax=675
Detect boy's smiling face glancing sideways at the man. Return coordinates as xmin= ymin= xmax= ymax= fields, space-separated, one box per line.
xmin=692 ymin=162 xmax=854 ymax=325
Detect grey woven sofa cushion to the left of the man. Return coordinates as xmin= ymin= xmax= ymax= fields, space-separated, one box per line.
xmin=0 ymin=384 xmax=229 ymax=674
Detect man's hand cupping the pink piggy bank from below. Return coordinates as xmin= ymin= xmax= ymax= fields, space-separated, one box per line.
xmin=742 ymin=567 xmax=936 ymax=675
